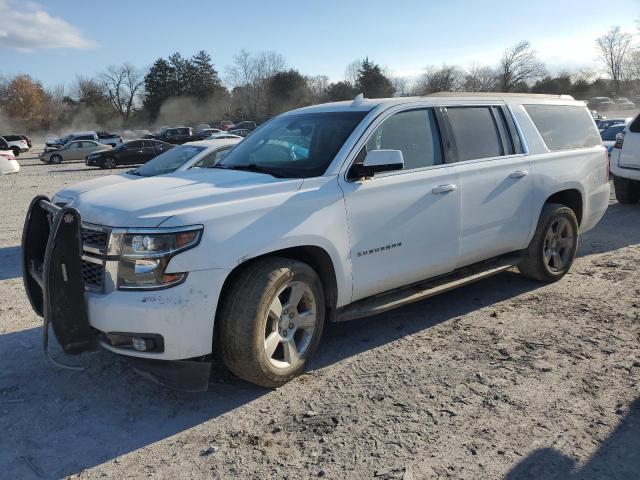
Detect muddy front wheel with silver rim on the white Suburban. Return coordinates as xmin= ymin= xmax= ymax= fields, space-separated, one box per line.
xmin=218 ymin=257 xmax=325 ymax=388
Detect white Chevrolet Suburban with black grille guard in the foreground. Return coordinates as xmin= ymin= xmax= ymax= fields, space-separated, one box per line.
xmin=23 ymin=95 xmax=609 ymax=389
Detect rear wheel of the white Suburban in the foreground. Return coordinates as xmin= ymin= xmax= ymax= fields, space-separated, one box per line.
xmin=518 ymin=203 xmax=578 ymax=283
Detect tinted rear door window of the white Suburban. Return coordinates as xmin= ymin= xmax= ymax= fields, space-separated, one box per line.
xmin=447 ymin=107 xmax=503 ymax=162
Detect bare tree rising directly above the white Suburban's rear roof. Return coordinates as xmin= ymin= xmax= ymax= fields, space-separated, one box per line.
xmin=499 ymin=40 xmax=546 ymax=92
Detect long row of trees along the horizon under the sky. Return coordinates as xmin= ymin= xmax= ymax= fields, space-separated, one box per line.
xmin=0 ymin=27 xmax=640 ymax=131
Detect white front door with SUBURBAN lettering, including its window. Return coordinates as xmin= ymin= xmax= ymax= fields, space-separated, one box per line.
xmin=340 ymin=108 xmax=460 ymax=300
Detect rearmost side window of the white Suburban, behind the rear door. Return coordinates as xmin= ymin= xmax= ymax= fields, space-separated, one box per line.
xmin=524 ymin=105 xmax=602 ymax=151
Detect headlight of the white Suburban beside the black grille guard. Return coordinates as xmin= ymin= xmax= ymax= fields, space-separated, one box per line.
xmin=118 ymin=226 xmax=202 ymax=290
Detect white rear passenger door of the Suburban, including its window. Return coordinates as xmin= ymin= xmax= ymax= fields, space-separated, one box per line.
xmin=444 ymin=105 xmax=533 ymax=268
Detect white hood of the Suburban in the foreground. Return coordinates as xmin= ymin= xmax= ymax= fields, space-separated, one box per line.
xmin=73 ymin=169 xmax=302 ymax=228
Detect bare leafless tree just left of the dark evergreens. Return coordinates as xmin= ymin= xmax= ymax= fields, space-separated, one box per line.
xmin=98 ymin=63 xmax=144 ymax=122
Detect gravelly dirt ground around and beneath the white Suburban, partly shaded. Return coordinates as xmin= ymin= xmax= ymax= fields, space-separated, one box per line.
xmin=0 ymin=150 xmax=640 ymax=479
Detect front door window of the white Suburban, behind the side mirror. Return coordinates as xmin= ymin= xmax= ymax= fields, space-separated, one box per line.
xmin=366 ymin=108 xmax=442 ymax=170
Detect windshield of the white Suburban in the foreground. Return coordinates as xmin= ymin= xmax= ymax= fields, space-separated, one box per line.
xmin=217 ymin=111 xmax=367 ymax=178
